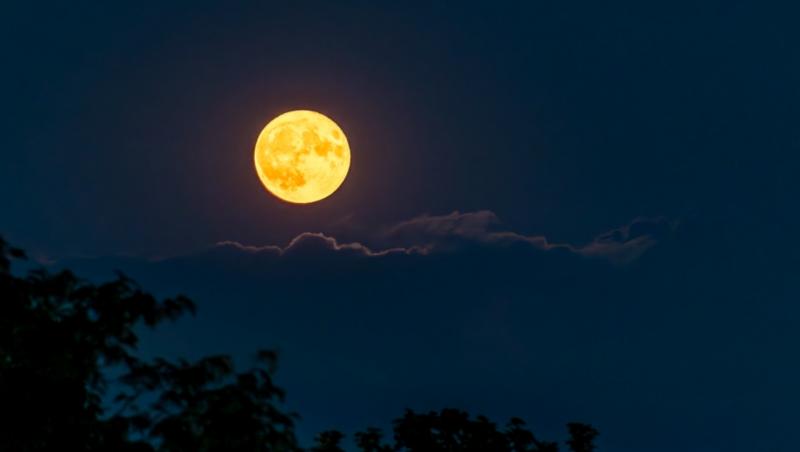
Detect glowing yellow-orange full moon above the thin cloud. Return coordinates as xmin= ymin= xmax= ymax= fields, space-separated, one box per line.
xmin=255 ymin=110 xmax=350 ymax=204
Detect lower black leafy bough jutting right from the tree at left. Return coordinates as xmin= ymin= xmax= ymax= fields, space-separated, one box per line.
xmin=123 ymin=351 xmax=298 ymax=452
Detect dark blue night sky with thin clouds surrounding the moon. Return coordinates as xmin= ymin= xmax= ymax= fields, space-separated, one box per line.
xmin=0 ymin=0 xmax=800 ymax=452
